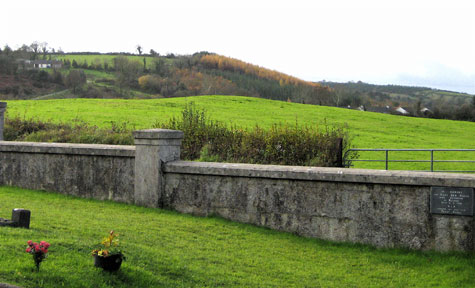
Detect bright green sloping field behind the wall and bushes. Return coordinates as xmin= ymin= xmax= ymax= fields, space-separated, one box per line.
xmin=3 ymin=96 xmax=475 ymax=170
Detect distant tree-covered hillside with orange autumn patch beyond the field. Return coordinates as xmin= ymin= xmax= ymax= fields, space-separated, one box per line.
xmin=0 ymin=49 xmax=475 ymax=121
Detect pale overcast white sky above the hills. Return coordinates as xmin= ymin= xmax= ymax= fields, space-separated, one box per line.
xmin=0 ymin=0 xmax=475 ymax=94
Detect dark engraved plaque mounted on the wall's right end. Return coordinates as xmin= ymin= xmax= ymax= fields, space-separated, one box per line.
xmin=430 ymin=187 xmax=474 ymax=216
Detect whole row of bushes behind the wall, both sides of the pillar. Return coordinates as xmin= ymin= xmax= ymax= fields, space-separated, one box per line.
xmin=4 ymin=103 xmax=356 ymax=167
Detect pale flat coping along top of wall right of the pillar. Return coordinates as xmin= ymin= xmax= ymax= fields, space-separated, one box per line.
xmin=164 ymin=161 xmax=475 ymax=188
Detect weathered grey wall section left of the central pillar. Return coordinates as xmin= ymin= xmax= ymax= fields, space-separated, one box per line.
xmin=0 ymin=141 xmax=135 ymax=203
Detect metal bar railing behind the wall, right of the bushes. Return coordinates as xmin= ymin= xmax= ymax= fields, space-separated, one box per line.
xmin=343 ymin=149 xmax=475 ymax=173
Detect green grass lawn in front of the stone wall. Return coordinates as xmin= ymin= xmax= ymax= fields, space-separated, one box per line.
xmin=0 ymin=187 xmax=475 ymax=287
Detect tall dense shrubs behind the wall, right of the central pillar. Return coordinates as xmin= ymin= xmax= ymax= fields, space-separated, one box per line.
xmin=154 ymin=104 xmax=356 ymax=167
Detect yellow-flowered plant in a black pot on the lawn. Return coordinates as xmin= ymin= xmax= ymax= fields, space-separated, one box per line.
xmin=92 ymin=230 xmax=125 ymax=272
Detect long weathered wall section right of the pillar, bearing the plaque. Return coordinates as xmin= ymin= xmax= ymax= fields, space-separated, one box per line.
xmin=164 ymin=161 xmax=475 ymax=251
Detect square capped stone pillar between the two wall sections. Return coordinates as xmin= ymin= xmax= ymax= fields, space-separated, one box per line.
xmin=134 ymin=129 xmax=183 ymax=207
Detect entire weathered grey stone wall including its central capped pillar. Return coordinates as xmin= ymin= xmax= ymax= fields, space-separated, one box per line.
xmin=0 ymin=129 xmax=475 ymax=251
